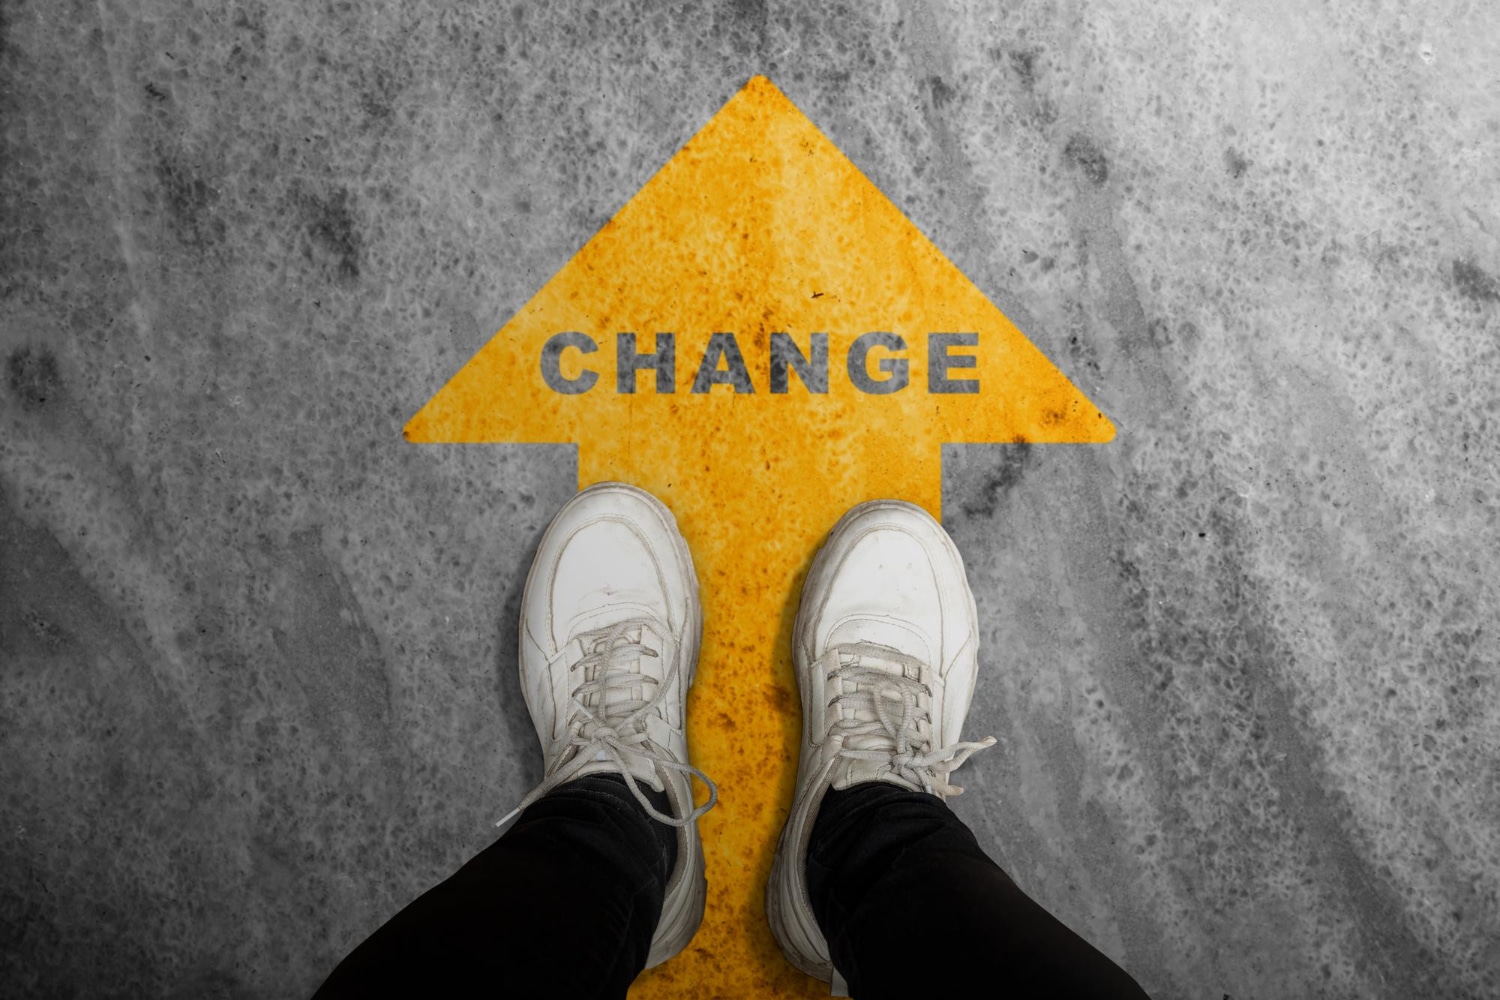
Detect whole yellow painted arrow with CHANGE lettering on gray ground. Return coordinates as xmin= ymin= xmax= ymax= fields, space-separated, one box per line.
xmin=407 ymin=76 xmax=1115 ymax=997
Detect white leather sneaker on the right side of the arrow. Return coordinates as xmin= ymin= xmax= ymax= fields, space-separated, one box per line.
xmin=765 ymin=501 xmax=995 ymax=982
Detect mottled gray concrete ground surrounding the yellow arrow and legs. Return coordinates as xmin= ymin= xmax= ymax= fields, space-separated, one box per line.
xmin=0 ymin=0 xmax=1500 ymax=1000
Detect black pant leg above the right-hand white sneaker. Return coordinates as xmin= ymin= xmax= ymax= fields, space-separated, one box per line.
xmin=807 ymin=783 xmax=1146 ymax=1000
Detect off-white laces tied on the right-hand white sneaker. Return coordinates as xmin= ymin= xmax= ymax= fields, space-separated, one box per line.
xmin=819 ymin=642 xmax=995 ymax=796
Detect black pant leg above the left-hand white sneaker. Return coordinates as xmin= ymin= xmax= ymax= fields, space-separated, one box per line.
xmin=315 ymin=775 xmax=677 ymax=1000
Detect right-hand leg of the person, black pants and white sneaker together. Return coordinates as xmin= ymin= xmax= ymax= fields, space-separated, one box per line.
xmin=765 ymin=501 xmax=1143 ymax=1000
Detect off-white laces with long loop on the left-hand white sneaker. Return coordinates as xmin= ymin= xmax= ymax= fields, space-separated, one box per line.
xmin=495 ymin=618 xmax=719 ymax=826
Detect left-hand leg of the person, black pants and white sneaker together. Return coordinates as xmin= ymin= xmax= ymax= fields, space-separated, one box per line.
xmin=320 ymin=483 xmax=719 ymax=997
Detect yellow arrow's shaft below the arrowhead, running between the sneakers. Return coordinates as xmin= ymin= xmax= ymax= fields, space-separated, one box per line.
xmin=579 ymin=449 xmax=942 ymax=996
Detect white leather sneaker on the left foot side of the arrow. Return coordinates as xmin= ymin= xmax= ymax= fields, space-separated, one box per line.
xmin=501 ymin=483 xmax=719 ymax=967
